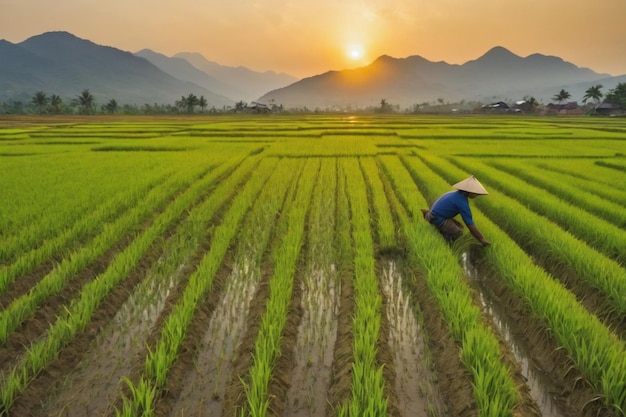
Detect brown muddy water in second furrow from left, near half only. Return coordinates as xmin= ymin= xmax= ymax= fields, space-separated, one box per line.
xmin=171 ymin=260 xmax=261 ymax=417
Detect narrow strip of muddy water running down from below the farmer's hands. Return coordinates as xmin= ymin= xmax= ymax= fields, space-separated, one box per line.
xmin=461 ymin=252 xmax=564 ymax=417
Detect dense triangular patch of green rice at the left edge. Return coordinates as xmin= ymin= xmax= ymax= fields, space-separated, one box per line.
xmin=0 ymin=154 xmax=169 ymax=258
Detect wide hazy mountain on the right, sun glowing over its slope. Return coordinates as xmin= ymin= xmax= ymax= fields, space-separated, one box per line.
xmin=260 ymin=46 xmax=620 ymax=109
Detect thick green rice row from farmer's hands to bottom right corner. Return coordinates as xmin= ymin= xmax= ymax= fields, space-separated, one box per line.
xmin=420 ymin=151 xmax=626 ymax=411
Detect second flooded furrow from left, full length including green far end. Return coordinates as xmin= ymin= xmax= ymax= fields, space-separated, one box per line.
xmin=167 ymin=161 xmax=298 ymax=416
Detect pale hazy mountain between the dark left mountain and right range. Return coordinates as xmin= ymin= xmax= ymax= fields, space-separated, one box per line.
xmin=174 ymin=52 xmax=298 ymax=101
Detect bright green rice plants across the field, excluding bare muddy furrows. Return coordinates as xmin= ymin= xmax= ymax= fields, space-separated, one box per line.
xmin=0 ymin=115 xmax=626 ymax=417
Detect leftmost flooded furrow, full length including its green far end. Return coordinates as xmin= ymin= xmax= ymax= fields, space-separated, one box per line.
xmin=33 ymin=162 xmax=254 ymax=416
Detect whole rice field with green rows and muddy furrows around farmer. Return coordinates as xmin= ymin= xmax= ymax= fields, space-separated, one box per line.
xmin=0 ymin=115 xmax=626 ymax=417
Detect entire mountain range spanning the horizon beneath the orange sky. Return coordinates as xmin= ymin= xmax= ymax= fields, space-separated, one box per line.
xmin=0 ymin=31 xmax=626 ymax=109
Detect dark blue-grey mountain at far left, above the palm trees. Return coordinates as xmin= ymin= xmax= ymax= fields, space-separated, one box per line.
xmin=0 ymin=32 xmax=234 ymax=108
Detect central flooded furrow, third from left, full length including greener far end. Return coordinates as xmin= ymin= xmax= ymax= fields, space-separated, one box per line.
xmin=282 ymin=160 xmax=341 ymax=417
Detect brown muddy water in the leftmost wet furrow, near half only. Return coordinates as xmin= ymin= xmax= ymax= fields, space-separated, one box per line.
xmin=48 ymin=265 xmax=184 ymax=417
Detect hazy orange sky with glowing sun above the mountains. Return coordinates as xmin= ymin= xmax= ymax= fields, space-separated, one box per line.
xmin=0 ymin=0 xmax=626 ymax=77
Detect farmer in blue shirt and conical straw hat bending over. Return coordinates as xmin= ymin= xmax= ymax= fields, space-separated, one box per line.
xmin=422 ymin=175 xmax=490 ymax=246
